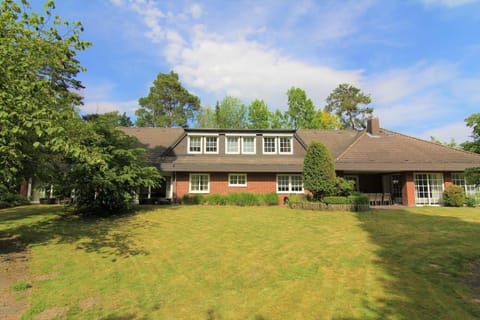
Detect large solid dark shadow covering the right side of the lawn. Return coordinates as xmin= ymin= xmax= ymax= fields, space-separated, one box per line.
xmin=357 ymin=209 xmax=480 ymax=319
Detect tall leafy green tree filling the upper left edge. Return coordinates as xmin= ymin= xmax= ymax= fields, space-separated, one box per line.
xmin=0 ymin=0 xmax=90 ymax=191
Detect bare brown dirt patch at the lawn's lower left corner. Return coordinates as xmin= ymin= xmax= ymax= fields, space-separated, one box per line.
xmin=0 ymin=233 xmax=31 ymax=319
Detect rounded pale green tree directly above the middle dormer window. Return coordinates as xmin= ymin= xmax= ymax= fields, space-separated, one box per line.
xmin=215 ymin=96 xmax=247 ymax=129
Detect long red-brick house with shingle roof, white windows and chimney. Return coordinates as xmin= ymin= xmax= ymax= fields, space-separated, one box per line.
xmin=122 ymin=119 xmax=480 ymax=206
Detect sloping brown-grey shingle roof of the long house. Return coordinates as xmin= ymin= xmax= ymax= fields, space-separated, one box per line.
xmin=122 ymin=128 xmax=480 ymax=172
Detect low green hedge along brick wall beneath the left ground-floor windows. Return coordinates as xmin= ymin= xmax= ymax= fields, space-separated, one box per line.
xmin=181 ymin=192 xmax=279 ymax=206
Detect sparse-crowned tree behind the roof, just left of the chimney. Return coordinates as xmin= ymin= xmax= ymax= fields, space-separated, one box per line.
xmin=324 ymin=83 xmax=373 ymax=129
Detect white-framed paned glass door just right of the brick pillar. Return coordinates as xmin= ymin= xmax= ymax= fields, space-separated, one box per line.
xmin=414 ymin=173 xmax=443 ymax=206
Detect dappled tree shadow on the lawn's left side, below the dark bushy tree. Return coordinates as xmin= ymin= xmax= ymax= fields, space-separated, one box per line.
xmin=0 ymin=206 xmax=180 ymax=258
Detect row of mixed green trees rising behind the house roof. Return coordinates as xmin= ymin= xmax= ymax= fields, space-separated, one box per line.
xmin=135 ymin=71 xmax=373 ymax=129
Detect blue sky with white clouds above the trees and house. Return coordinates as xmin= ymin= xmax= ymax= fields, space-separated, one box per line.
xmin=50 ymin=0 xmax=480 ymax=142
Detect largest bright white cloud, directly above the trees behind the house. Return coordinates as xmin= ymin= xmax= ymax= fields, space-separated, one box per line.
xmin=174 ymin=28 xmax=361 ymax=108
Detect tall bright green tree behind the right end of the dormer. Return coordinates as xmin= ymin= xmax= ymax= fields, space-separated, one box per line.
xmin=285 ymin=87 xmax=316 ymax=129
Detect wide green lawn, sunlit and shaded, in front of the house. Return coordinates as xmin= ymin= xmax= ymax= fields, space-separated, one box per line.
xmin=0 ymin=206 xmax=480 ymax=319
